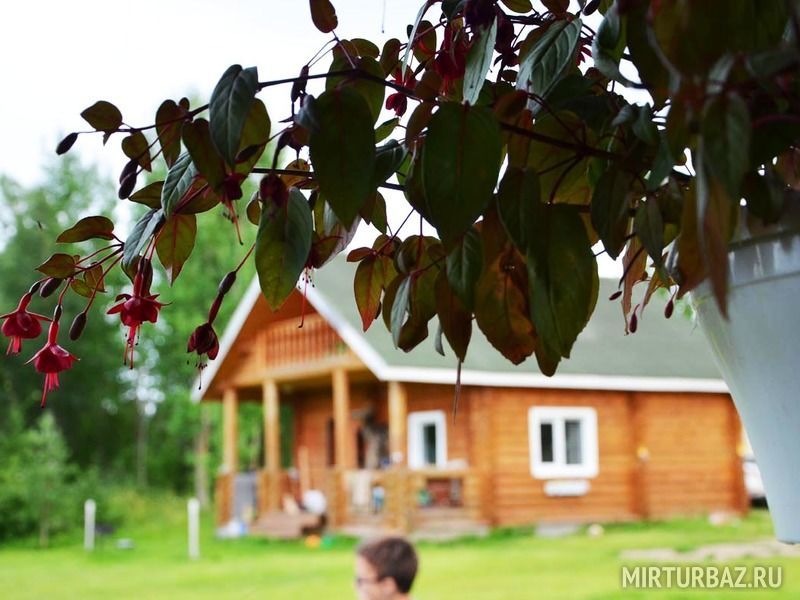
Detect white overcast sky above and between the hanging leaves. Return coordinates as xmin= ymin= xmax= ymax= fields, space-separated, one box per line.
xmin=0 ymin=0 xmax=613 ymax=272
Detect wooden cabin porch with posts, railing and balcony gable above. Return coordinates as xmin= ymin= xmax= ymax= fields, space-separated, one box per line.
xmin=215 ymin=314 xmax=489 ymax=537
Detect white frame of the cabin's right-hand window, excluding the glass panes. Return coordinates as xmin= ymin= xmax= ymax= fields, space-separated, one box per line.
xmin=528 ymin=406 xmax=599 ymax=479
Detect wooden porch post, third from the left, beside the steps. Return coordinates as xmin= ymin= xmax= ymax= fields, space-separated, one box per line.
xmin=328 ymin=368 xmax=354 ymax=526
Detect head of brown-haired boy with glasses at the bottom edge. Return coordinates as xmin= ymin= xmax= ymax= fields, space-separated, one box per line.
xmin=356 ymin=537 xmax=417 ymax=600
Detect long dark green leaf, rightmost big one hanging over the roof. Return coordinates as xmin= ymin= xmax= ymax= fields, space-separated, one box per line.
xmin=528 ymin=205 xmax=599 ymax=358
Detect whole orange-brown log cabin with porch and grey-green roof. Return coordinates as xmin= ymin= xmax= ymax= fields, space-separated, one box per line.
xmin=195 ymin=259 xmax=748 ymax=533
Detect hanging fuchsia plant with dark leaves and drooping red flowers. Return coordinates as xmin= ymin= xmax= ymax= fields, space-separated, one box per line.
xmin=1 ymin=0 xmax=800 ymax=404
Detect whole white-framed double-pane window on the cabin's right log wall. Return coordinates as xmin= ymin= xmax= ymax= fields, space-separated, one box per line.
xmin=528 ymin=406 xmax=598 ymax=479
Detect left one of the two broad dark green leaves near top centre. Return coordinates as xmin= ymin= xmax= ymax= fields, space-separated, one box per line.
xmin=309 ymin=87 xmax=375 ymax=227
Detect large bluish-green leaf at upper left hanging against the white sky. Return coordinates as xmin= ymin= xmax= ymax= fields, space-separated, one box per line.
xmin=208 ymin=65 xmax=258 ymax=166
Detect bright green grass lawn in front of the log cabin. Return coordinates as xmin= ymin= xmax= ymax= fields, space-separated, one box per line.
xmin=0 ymin=494 xmax=800 ymax=600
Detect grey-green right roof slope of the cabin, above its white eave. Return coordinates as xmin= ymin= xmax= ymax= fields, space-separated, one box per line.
xmin=309 ymin=256 xmax=726 ymax=391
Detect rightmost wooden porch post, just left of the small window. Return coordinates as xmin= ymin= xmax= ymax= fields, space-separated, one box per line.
xmin=386 ymin=381 xmax=411 ymax=532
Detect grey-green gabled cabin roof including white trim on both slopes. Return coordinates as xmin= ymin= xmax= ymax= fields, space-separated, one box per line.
xmin=194 ymin=256 xmax=728 ymax=400
